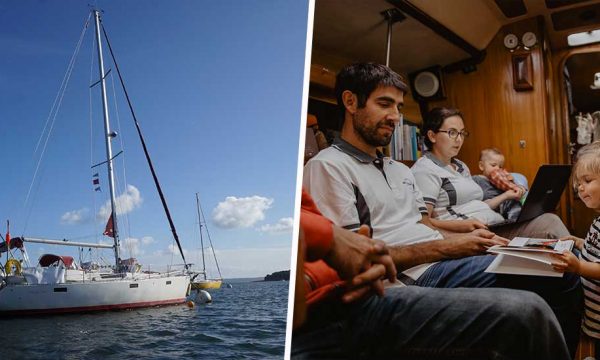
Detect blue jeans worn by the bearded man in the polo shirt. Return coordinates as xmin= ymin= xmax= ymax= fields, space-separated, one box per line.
xmin=415 ymin=255 xmax=583 ymax=359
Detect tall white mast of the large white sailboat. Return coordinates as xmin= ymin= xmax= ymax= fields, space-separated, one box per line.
xmin=94 ymin=10 xmax=119 ymax=270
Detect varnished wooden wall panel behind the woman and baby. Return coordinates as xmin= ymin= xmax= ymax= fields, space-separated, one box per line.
xmin=429 ymin=19 xmax=548 ymax=182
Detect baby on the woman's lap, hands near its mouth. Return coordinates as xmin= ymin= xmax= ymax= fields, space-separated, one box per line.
xmin=473 ymin=148 xmax=527 ymax=220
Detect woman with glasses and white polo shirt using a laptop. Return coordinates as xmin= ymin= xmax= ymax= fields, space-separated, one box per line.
xmin=412 ymin=108 xmax=569 ymax=239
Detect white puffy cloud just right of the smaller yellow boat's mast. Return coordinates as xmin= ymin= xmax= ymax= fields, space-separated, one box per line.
xmin=212 ymin=195 xmax=273 ymax=229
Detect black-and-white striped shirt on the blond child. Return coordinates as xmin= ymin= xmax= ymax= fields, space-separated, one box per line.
xmin=579 ymin=217 xmax=600 ymax=339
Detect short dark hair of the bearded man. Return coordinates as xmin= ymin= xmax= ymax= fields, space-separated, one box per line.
xmin=335 ymin=63 xmax=408 ymax=121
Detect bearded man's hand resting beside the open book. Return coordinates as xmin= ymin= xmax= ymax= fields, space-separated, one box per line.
xmin=442 ymin=229 xmax=509 ymax=259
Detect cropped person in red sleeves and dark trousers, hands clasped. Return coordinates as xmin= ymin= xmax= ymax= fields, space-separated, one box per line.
xmin=292 ymin=193 xmax=569 ymax=359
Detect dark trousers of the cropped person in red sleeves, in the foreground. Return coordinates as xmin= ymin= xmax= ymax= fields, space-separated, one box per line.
xmin=291 ymin=286 xmax=570 ymax=360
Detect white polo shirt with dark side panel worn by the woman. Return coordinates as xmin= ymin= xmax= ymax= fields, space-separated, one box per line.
xmin=411 ymin=152 xmax=504 ymax=225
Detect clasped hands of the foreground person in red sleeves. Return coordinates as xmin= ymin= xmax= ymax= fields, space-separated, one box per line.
xmin=324 ymin=225 xmax=396 ymax=302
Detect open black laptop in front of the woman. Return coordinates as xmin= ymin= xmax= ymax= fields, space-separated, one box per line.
xmin=489 ymin=165 xmax=571 ymax=230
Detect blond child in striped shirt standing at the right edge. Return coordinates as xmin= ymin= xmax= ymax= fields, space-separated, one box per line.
xmin=552 ymin=141 xmax=600 ymax=348
